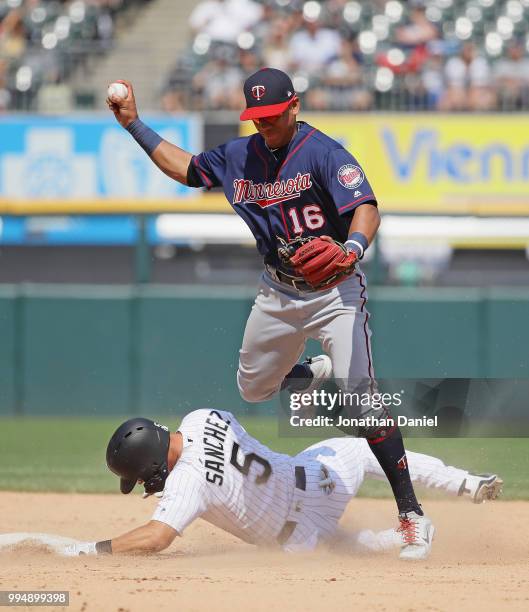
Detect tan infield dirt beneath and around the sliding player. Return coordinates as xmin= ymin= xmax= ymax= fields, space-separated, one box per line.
xmin=0 ymin=492 xmax=529 ymax=612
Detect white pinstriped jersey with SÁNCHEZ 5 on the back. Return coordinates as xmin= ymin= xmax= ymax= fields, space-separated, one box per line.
xmin=153 ymin=410 xmax=295 ymax=543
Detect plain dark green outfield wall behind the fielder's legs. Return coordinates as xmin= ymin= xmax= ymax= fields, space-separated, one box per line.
xmin=0 ymin=285 xmax=529 ymax=416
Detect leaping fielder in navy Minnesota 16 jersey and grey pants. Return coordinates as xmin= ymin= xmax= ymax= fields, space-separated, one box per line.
xmin=107 ymin=68 xmax=433 ymax=558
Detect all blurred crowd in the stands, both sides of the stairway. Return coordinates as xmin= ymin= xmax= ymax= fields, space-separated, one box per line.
xmin=0 ymin=0 xmax=529 ymax=112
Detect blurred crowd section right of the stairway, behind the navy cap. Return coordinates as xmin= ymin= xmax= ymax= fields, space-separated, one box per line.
xmin=163 ymin=0 xmax=529 ymax=111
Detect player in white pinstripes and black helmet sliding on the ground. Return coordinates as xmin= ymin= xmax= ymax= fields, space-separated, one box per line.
xmin=60 ymin=409 xmax=503 ymax=556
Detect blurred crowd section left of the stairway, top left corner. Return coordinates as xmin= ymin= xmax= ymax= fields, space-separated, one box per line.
xmin=0 ymin=0 xmax=149 ymax=112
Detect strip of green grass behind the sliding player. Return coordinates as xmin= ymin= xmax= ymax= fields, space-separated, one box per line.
xmin=0 ymin=418 xmax=529 ymax=499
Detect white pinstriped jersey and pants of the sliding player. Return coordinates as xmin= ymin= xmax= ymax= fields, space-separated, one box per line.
xmin=152 ymin=409 xmax=467 ymax=551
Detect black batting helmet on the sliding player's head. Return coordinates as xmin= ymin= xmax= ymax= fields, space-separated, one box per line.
xmin=107 ymin=417 xmax=170 ymax=493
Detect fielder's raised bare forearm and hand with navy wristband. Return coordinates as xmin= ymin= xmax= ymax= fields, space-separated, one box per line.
xmin=107 ymin=80 xmax=193 ymax=185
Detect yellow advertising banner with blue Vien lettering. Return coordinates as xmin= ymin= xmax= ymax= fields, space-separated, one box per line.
xmin=242 ymin=113 xmax=529 ymax=215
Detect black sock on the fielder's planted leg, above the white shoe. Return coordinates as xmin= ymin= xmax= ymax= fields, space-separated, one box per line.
xmin=368 ymin=428 xmax=423 ymax=515
